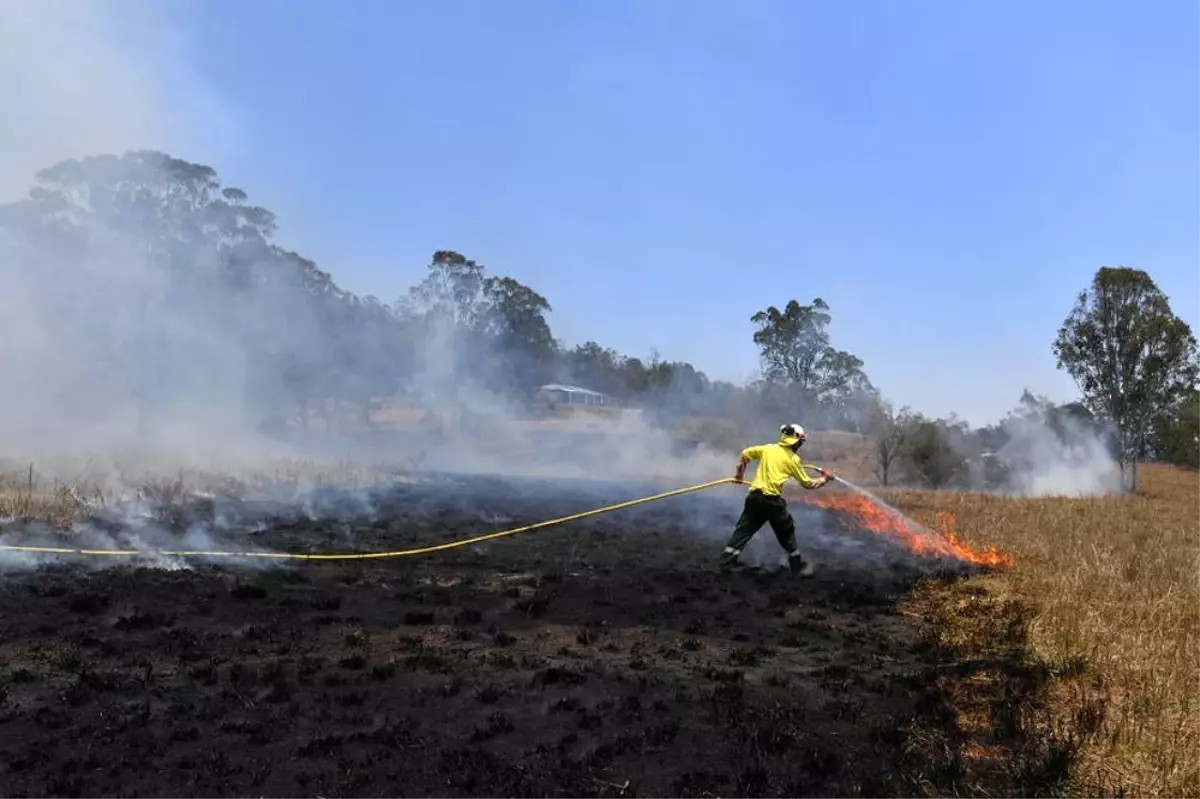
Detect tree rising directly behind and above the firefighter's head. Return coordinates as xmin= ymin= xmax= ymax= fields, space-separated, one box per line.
xmin=750 ymin=298 xmax=870 ymax=404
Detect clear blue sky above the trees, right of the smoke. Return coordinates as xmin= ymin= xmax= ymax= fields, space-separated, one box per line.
xmin=169 ymin=0 xmax=1200 ymax=423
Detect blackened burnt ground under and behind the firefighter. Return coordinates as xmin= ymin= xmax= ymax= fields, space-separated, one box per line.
xmin=0 ymin=481 xmax=984 ymax=799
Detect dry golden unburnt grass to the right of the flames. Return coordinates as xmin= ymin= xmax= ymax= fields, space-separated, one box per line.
xmin=888 ymin=464 xmax=1200 ymax=797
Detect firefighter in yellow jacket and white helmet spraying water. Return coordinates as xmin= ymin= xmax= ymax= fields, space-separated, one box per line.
xmin=720 ymin=425 xmax=833 ymax=577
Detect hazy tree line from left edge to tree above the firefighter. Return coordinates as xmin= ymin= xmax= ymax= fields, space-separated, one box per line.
xmin=0 ymin=151 xmax=892 ymax=439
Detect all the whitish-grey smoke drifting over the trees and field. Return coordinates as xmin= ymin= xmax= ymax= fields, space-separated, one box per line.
xmin=0 ymin=0 xmax=1051 ymax=578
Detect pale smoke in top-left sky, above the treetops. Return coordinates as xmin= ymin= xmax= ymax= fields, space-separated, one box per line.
xmin=0 ymin=0 xmax=236 ymax=202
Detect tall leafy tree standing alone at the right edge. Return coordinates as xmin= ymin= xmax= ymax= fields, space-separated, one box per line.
xmin=1052 ymin=266 xmax=1200 ymax=491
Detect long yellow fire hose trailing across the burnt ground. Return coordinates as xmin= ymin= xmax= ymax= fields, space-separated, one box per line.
xmin=0 ymin=477 xmax=737 ymax=560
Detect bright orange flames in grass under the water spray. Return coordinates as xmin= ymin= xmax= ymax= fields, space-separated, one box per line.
xmin=794 ymin=491 xmax=1013 ymax=567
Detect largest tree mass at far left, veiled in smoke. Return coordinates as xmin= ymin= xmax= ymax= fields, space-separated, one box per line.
xmin=0 ymin=150 xmax=401 ymax=436
